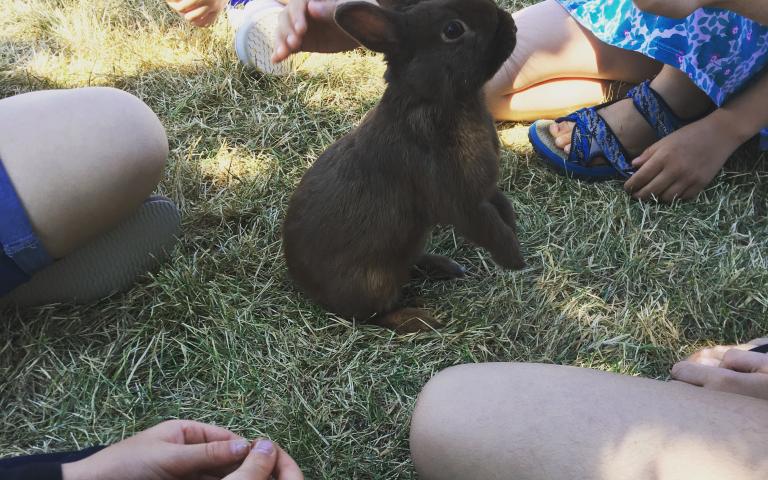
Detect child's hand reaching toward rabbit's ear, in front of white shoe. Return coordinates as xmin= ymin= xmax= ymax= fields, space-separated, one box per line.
xmin=272 ymin=0 xmax=358 ymax=63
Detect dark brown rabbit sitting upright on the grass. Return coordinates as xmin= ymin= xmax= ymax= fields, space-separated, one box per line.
xmin=283 ymin=0 xmax=524 ymax=332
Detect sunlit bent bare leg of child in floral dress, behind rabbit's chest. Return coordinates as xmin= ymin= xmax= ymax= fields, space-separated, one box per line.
xmin=486 ymin=0 xmax=661 ymax=120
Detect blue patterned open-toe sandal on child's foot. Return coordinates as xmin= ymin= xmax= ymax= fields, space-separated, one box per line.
xmin=528 ymin=80 xmax=696 ymax=181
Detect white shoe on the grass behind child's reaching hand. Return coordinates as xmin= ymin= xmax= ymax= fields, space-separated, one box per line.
xmin=230 ymin=0 xmax=308 ymax=76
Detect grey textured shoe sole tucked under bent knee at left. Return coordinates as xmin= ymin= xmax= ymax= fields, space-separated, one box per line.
xmin=0 ymin=197 xmax=181 ymax=307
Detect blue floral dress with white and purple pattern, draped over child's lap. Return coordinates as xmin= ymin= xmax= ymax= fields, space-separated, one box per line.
xmin=557 ymin=0 xmax=768 ymax=150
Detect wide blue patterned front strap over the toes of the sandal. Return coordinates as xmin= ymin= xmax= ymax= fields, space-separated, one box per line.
xmin=555 ymin=106 xmax=635 ymax=178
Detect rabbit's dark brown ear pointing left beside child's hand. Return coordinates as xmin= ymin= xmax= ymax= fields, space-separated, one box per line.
xmin=335 ymin=2 xmax=398 ymax=53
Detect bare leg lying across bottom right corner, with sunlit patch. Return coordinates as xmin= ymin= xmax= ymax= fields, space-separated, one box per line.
xmin=411 ymin=363 xmax=768 ymax=480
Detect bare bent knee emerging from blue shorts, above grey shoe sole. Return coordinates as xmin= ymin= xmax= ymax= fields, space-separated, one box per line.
xmin=0 ymin=88 xmax=168 ymax=258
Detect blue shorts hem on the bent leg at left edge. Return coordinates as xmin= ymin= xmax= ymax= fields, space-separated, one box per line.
xmin=0 ymin=160 xmax=53 ymax=297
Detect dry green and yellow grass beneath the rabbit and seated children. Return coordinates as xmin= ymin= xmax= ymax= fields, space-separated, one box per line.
xmin=0 ymin=0 xmax=768 ymax=479
